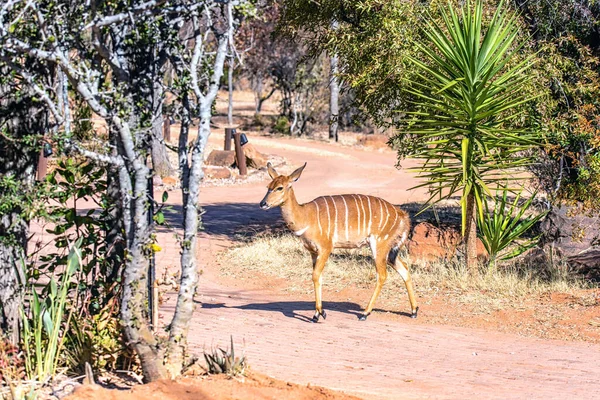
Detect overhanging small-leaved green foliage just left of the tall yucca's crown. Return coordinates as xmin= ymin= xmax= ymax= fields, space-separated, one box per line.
xmin=279 ymin=0 xmax=423 ymax=126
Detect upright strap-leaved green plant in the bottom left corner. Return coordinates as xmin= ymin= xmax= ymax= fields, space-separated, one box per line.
xmin=22 ymin=240 xmax=82 ymax=384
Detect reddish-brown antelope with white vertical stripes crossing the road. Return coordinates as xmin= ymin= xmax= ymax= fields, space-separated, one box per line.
xmin=260 ymin=163 xmax=419 ymax=322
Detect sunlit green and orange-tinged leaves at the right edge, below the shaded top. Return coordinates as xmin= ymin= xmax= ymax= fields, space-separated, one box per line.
xmin=533 ymin=34 xmax=600 ymax=210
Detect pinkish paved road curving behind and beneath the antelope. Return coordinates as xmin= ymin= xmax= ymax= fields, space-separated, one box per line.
xmin=157 ymin=137 xmax=600 ymax=399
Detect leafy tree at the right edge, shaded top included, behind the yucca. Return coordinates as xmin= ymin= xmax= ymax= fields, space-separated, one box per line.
xmin=513 ymin=0 xmax=600 ymax=210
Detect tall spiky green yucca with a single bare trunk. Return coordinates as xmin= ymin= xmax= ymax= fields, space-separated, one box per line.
xmin=396 ymin=1 xmax=538 ymax=270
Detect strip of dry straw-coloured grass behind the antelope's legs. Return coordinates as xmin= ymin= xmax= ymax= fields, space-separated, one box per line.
xmin=221 ymin=233 xmax=589 ymax=304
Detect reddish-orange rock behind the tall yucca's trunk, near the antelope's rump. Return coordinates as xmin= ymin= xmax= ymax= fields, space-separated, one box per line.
xmin=408 ymin=222 xmax=487 ymax=261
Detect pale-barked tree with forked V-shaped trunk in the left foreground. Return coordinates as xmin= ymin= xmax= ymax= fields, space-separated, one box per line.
xmin=0 ymin=0 xmax=244 ymax=380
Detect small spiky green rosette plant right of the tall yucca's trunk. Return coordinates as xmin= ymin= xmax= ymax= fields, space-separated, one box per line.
xmin=477 ymin=188 xmax=547 ymax=266
